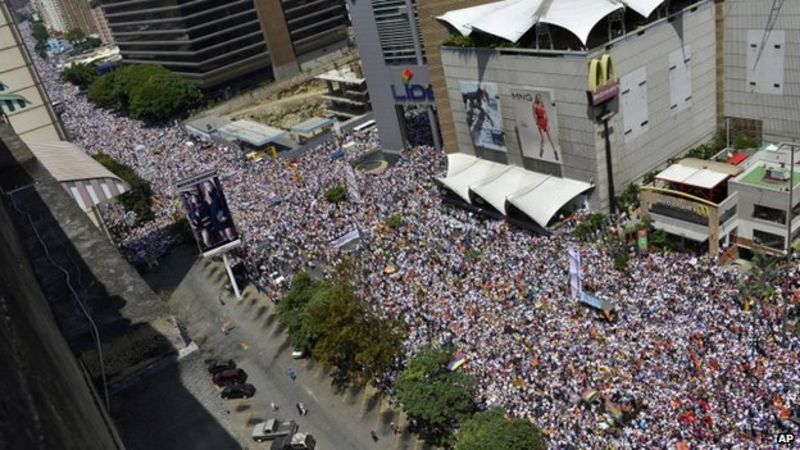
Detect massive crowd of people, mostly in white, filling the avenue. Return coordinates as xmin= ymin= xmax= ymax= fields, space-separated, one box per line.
xmin=20 ymin=22 xmax=800 ymax=449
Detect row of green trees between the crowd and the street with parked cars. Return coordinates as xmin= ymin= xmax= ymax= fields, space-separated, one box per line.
xmin=278 ymin=259 xmax=547 ymax=450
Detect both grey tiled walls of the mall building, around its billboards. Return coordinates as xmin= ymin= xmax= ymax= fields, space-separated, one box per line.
xmin=437 ymin=2 xmax=716 ymax=208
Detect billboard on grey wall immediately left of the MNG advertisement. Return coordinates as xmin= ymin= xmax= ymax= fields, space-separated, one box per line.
xmin=460 ymin=81 xmax=506 ymax=152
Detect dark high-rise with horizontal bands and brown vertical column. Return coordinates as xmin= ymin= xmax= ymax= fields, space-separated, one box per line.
xmin=102 ymin=0 xmax=347 ymax=88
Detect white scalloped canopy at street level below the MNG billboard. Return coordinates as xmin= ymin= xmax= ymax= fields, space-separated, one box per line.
xmin=437 ymin=153 xmax=592 ymax=227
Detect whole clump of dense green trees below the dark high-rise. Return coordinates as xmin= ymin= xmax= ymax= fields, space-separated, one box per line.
xmin=85 ymin=65 xmax=202 ymax=121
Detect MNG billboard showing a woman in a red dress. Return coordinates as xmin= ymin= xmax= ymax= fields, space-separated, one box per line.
xmin=509 ymin=88 xmax=562 ymax=164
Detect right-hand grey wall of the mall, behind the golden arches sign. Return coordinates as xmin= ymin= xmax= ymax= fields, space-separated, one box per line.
xmin=593 ymin=2 xmax=716 ymax=192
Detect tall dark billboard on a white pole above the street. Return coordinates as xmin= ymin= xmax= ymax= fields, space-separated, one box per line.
xmin=177 ymin=170 xmax=240 ymax=256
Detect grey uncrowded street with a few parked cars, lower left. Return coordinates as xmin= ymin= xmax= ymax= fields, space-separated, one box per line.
xmin=120 ymin=246 xmax=425 ymax=450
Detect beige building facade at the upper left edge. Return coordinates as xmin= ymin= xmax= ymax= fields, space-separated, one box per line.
xmin=0 ymin=2 xmax=65 ymax=142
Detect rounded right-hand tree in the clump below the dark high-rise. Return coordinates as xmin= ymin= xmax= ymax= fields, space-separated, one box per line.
xmin=129 ymin=68 xmax=201 ymax=121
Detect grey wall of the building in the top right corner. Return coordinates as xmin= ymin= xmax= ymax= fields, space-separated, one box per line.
xmin=723 ymin=0 xmax=800 ymax=142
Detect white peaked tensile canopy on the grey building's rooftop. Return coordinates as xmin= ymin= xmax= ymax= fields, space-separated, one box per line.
xmin=437 ymin=0 xmax=664 ymax=45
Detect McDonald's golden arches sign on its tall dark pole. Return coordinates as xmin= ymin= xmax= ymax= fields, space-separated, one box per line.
xmin=586 ymin=54 xmax=619 ymax=216
